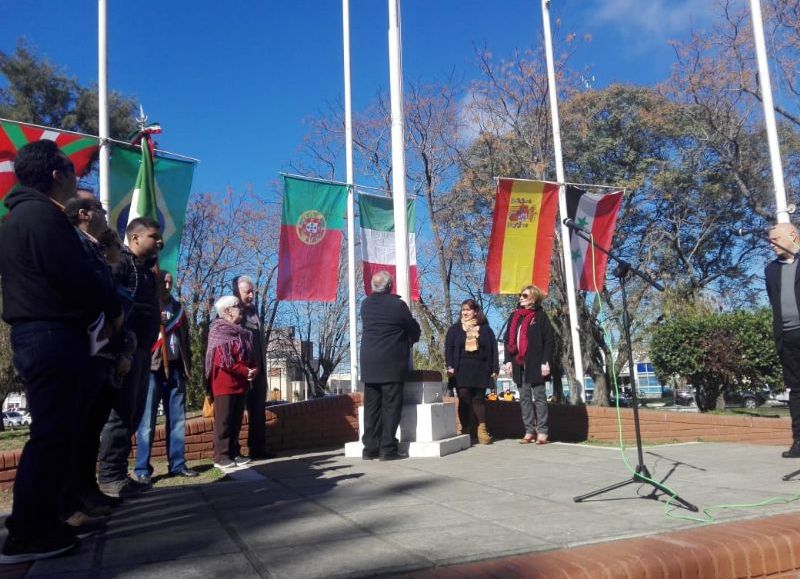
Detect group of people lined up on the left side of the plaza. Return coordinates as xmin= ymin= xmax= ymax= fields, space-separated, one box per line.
xmin=0 ymin=140 xmax=274 ymax=564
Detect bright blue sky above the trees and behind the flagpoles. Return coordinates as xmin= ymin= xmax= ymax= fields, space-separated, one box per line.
xmin=0 ymin=0 xmax=711 ymax=198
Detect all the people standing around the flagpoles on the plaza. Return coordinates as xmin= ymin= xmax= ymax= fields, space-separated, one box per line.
xmin=0 ymin=140 xmax=800 ymax=563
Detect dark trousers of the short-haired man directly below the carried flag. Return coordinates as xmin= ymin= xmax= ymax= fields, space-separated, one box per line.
xmin=98 ymin=348 xmax=150 ymax=483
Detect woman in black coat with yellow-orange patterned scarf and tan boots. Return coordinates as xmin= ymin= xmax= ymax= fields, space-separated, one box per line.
xmin=444 ymin=300 xmax=500 ymax=444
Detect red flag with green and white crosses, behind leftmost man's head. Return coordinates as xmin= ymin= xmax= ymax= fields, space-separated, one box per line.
xmin=0 ymin=121 xmax=100 ymax=217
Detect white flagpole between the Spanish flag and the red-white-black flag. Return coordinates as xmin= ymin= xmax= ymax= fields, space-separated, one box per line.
xmin=542 ymin=0 xmax=584 ymax=402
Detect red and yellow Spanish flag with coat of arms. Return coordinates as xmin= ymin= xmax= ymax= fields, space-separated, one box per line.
xmin=483 ymin=179 xmax=558 ymax=294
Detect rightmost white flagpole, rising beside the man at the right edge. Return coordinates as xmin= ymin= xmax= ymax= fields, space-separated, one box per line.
xmin=750 ymin=0 xmax=789 ymax=223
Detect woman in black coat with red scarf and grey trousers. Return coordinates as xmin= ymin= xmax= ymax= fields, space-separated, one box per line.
xmin=504 ymin=285 xmax=553 ymax=444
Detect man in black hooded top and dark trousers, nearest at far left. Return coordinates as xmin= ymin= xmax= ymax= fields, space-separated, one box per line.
xmin=0 ymin=140 xmax=122 ymax=563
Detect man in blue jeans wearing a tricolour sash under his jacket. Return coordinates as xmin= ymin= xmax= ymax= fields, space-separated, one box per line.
xmin=133 ymin=271 xmax=198 ymax=484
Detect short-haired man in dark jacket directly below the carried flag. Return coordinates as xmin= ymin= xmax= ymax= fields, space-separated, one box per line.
xmin=98 ymin=217 xmax=163 ymax=498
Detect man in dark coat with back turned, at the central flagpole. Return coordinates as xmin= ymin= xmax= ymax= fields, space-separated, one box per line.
xmin=360 ymin=271 xmax=420 ymax=460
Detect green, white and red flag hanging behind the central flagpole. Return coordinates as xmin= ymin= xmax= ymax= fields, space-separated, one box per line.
xmin=358 ymin=193 xmax=419 ymax=301
